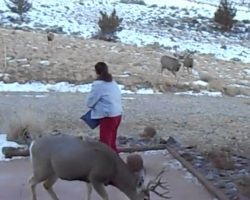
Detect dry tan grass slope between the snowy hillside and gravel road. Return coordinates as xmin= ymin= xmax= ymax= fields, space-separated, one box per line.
xmin=0 ymin=29 xmax=248 ymax=97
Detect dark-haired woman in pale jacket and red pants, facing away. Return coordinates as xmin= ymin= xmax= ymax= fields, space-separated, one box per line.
xmin=87 ymin=62 xmax=122 ymax=153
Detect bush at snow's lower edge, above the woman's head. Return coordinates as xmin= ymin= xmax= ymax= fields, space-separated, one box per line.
xmin=98 ymin=9 xmax=122 ymax=41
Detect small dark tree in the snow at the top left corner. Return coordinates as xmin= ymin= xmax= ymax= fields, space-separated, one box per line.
xmin=5 ymin=0 xmax=32 ymax=21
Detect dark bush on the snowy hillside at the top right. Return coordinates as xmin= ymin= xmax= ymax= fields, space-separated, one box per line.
xmin=214 ymin=0 xmax=237 ymax=31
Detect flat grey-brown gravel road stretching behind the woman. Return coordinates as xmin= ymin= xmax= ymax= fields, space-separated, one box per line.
xmin=0 ymin=93 xmax=250 ymax=156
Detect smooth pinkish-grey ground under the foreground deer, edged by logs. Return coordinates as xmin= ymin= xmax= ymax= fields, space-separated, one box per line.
xmin=0 ymin=152 xmax=214 ymax=200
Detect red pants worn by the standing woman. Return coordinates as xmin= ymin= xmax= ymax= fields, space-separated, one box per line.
xmin=100 ymin=115 xmax=122 ymax=153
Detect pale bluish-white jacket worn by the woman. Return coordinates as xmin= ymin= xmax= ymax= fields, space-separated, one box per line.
xmin=87 ymin=80 xmax=122 ymax=119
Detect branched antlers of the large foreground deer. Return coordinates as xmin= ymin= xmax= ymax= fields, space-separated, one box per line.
xmin=146 ymin=168 xmax=170 ymax=199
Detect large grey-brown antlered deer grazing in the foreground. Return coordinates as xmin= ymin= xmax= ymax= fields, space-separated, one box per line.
xmin=29 ymin=134 xmax=169 ymax=200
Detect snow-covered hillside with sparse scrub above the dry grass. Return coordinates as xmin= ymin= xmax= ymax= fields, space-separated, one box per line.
xmin=0 ymin=0 xmax=250 ymax=62
